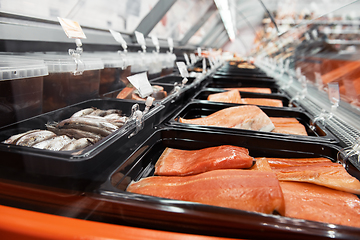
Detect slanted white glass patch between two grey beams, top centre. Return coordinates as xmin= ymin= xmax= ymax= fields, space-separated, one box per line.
xmin=150 ymin=0 xmax=214 ymax=40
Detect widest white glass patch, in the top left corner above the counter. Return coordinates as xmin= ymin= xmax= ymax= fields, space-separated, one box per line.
xmin=0 ymin=0 xmax=158 ymax=33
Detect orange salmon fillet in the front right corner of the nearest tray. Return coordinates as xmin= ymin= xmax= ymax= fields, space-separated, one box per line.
xmin=280 ymin=181 xmax=360 ymax=227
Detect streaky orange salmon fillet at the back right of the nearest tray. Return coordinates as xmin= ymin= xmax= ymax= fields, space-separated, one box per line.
xmin=256 ymin=158 xmax=360 ymax=194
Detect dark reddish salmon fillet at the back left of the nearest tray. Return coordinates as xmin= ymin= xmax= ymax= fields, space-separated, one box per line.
xmin=155 ymin=145 xmax=254 ymax=176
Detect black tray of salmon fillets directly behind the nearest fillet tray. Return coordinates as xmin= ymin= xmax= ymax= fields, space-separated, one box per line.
xmin=165 ymin=100 xmax=339 ymax=143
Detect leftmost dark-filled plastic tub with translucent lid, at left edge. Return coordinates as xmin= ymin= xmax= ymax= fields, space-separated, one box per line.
xmin=0 ymin=55 xmax=48 ymax=127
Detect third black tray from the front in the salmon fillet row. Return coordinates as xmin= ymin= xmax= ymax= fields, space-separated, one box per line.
xmin=193 ymin=88 xmax=298 ymax=107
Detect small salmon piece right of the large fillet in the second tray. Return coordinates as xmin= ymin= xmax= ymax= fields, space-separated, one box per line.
xmin=270 ymin=117 xmax=307 ymax=136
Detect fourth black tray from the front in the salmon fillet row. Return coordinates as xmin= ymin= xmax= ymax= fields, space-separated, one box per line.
xmin=204 ymin=79 xmax=282 ymax=93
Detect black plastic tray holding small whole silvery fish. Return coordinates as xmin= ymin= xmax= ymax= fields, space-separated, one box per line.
xmin=0 ymin=99 xmax=163 ymax=179
